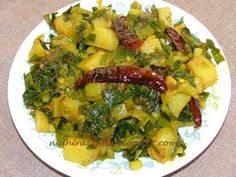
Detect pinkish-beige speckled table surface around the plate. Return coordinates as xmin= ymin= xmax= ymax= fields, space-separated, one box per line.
xmin=0 ymin=0 xmax=236 ymax=177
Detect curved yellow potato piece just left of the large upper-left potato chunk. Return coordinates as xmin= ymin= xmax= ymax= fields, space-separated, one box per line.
xmin=51 ymin=35 xmax=79 ymax=56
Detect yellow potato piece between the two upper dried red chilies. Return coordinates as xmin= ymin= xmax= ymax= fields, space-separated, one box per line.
xmin=140 ymin=36 xmax=163 ymax=54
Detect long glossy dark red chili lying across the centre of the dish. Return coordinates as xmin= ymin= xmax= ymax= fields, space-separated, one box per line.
xmin=74 ymin=66 xmax=167 ymax=92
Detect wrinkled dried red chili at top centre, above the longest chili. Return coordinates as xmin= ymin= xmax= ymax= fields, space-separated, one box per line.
xmin=113 ymin=16 xmax=143 ymax=50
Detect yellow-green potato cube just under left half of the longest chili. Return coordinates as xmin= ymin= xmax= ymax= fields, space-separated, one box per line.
xmin=84 ymin=83 xmax=105 ymax=101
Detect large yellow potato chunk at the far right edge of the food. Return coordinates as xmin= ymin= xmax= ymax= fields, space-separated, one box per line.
xmin=187 ymin=55 xmax=217 ymax=90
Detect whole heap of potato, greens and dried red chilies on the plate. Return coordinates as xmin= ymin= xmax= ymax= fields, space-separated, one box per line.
xmin=23 ymin=2 xmax=224 ymax=169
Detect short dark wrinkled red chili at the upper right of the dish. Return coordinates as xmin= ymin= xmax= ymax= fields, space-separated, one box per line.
xmin=165 ymin=27 xmax=191 ymax=53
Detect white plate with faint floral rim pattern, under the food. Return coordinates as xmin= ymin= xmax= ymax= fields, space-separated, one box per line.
xmin=8 ymin=0 xmax=231 ymax=177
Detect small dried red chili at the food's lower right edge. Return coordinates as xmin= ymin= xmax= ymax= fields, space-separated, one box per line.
xmin=189 ymin=98 xmax=202 ymax=128
